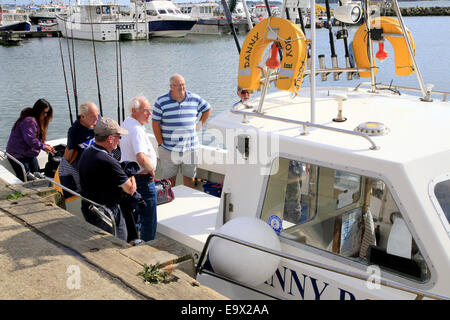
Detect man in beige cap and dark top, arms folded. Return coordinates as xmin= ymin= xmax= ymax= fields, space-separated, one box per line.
xmin=79 ymin=118 xmax=136 ymax=241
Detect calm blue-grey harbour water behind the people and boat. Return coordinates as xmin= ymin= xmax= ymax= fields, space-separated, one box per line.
xmin=0 ymin=1 xmax=450 ymax=149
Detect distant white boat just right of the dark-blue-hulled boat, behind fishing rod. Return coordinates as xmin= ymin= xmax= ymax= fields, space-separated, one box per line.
xmin=177 ymin=1 xmax=249 ymax=34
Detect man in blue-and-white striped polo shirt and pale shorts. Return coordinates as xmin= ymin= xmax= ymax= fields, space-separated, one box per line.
xmin=152 ymin=74 xmax=212 ymax=188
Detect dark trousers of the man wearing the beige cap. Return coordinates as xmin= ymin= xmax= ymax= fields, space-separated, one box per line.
xmin=81 ymin=200 xmax=128 ymax=241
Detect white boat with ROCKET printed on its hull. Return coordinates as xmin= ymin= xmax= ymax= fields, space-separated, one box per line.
xmin=56 ymin=0 xmax=148 ymax=41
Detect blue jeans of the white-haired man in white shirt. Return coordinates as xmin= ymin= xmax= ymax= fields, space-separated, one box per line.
xmin=135 ymin=175 xmax=158 ymax=241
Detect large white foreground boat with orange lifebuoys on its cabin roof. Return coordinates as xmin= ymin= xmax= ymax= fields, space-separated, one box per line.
xmin=0 ymin=1 xmax=450 ymax=300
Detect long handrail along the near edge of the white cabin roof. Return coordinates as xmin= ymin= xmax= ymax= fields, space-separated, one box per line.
xmin=231 ymin=105 xmax=380 ymax=150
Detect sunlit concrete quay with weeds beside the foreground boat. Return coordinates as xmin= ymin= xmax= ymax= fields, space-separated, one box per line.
xmin=0 ymin=180 xmax=226 ymax=300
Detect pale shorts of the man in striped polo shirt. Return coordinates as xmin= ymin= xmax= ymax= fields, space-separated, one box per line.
xmin=158 ymin=146 xmax=197 ymax=179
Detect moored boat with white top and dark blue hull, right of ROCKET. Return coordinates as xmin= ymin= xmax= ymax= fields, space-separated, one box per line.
xmin=130 ymin=0 xmax=197 ymax=38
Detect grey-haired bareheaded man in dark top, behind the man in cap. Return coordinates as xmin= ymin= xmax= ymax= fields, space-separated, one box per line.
xmin=58 ymin=101 xmax=99 ymax=198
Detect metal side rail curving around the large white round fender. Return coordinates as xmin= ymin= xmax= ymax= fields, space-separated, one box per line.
xmin=196 ymin=233 xmax=450 ymax=300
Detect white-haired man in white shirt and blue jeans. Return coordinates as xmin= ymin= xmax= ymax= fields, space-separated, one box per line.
xmin=120 ymin=97 xmax=157 ymax=241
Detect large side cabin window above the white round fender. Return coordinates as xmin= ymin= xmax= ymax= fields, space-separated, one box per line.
xmin=261 ymin=158 xmax=432 ymax=281
